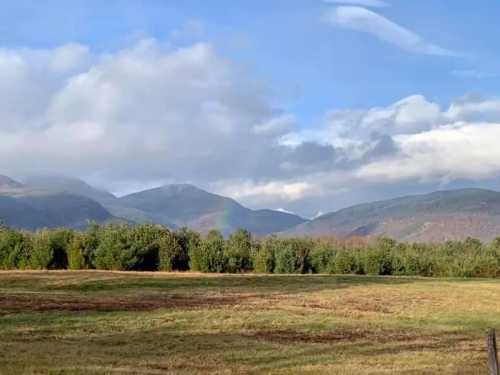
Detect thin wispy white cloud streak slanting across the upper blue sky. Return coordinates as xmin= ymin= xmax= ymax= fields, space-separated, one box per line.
xmin=325 ymin=6 xmax=456 ymax=56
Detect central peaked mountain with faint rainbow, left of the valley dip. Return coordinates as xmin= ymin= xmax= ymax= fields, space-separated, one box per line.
xmin=119 ymin=184 xmax=305 ymax=235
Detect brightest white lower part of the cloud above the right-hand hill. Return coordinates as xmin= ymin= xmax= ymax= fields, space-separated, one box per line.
xmin=356 ymin=123 xmax=500 ymax=182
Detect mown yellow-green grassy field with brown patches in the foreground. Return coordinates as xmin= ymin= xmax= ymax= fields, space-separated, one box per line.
xmin=0 ymin=271 xmax=500 ymax=374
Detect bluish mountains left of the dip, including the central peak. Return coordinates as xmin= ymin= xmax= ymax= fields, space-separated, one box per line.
xmin=0 ymin=176 xmax=305 ymax=235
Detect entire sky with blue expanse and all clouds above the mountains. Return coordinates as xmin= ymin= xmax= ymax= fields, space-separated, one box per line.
xmin=0 ymin=0 xmax=500 ymax=217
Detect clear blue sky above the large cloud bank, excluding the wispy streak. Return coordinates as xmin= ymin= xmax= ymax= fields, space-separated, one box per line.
xmin=0 ymin=0 xmax=500 ymax=119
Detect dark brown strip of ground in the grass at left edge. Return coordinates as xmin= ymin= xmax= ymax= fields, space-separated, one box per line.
xmin=0 ymin=294 xmax=242 ymax=314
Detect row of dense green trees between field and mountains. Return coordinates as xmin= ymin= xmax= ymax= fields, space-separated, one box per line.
xmin=0 ymin=223 xmax=500 ymax=277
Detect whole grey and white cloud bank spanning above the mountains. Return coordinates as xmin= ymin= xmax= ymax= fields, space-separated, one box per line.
xmin=0 ymin=39 xmax=500 ymax=215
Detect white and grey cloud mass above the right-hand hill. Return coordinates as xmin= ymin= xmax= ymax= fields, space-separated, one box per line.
xmin=270 ymin=95 xmax=500 ymax=213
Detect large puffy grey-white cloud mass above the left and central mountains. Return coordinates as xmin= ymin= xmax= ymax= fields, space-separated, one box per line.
xmin=0 ymin=39 xmax=335 ymax=206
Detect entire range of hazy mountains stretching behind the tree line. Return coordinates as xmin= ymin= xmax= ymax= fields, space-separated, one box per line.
xmin=0 ymin=176 xmax=500 ymax=242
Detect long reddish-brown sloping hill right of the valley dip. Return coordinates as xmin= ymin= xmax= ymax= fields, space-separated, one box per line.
xmin=284 ymin=189 xmax=500 ymax=242
